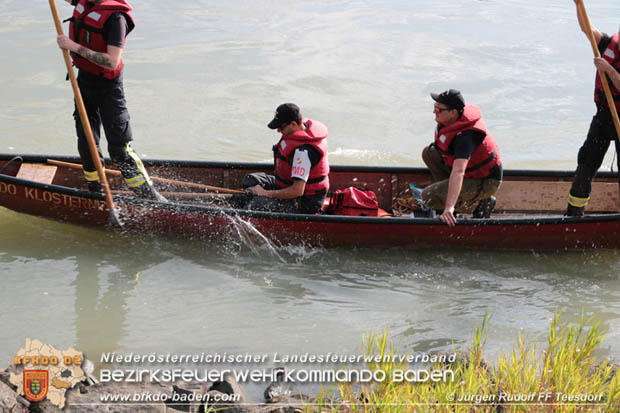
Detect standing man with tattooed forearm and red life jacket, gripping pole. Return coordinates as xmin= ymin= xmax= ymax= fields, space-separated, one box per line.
xmin=57 ymin=0 xmax=165 ymax=201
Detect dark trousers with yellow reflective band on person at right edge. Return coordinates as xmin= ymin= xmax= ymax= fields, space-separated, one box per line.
xmin=569 ymin=108 xmax=620 ymax=208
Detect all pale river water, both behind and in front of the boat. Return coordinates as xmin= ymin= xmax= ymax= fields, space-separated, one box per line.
xmin=0 ymin=0 xmax=620 ymax=396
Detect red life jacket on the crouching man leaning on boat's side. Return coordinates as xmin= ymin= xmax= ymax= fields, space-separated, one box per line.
xmin=435 ymin=105 xmax=502 ymax=179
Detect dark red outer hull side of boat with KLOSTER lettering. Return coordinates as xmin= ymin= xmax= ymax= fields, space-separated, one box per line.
xmin=0 ymin=174 xmax=620 ymax=250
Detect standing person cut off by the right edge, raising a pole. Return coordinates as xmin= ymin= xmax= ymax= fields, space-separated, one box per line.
xmin=566 ymin=0 xmax=620 ymax=216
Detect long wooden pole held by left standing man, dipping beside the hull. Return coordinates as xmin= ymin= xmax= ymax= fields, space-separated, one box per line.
xmin=49 ymin=0 xmax=121 ymax=226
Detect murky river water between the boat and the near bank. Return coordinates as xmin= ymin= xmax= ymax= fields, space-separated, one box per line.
xmin=0 ymin=208 xmax=620 ymax=368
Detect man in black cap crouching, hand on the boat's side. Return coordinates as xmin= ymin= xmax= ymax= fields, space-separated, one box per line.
xmin=422 ymin=89 xmax=503 ymax=226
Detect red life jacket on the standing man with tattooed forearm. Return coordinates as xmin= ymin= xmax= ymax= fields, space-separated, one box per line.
xmin=69 ymin=0 xmax=135 ymax=79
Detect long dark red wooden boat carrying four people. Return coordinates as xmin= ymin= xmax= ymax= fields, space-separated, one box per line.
xmin=0 ymin=154 xmax=620 ymax=250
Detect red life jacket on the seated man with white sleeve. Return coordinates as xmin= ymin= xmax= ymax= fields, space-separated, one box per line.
xmin=273 ymin=119 xmax=329 ymax=195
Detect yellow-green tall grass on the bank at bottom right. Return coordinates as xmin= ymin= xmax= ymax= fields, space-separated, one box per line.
xmin=306 ymin=313 xmax=620 ymax=413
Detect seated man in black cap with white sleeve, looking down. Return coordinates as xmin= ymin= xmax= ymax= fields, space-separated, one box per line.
xmin=241 ymin=103 xmax=329 ymax=214
